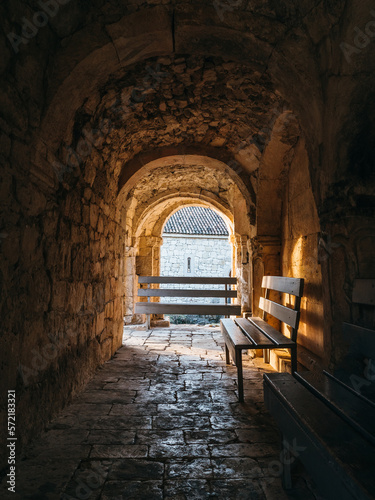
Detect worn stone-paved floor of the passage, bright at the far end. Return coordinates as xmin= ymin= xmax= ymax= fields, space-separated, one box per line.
xmin=2 ymin=325 xmax=315 ymax=500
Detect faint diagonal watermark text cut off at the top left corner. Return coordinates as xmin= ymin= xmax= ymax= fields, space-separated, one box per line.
xmin=7 ymin=0 xmax=71 ymax=54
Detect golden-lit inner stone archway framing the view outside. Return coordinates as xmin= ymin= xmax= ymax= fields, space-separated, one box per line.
xmin=119 ymin=155 xmax=255 ymax=321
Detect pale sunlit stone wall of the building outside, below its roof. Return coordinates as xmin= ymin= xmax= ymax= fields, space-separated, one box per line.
xmin=160 ymin=234 xmax=232 ymax=303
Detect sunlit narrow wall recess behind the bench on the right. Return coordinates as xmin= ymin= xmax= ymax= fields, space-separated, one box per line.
xmin=281 ymin=140 xmax=328 ymax=368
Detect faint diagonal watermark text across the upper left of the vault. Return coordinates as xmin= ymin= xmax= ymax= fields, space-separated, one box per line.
xmin=52 ymin=64 xmax=168 ymax=182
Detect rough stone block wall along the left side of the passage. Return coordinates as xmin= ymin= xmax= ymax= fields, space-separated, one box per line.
xmin=0 ymin=163 xmax=124 ymax=468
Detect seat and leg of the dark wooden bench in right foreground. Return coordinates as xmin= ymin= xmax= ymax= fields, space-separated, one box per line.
xmin=263 ymin=372 xmax=375 ymax=500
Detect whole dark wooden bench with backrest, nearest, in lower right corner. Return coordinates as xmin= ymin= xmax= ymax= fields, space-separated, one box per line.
xmin=263 ymin=280 xmax=375 ymax=500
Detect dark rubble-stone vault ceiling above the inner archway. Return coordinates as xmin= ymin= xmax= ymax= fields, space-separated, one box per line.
xmin=66 ymin=56 xmax=285 ymax=161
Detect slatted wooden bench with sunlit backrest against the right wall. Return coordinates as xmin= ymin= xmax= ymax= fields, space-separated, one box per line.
xmin=221 ymin=276 xmax=304 ymax=402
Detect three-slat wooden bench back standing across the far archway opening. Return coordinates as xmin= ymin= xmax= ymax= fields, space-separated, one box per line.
xmin=135 ymin=276 xmax=241 ymax=328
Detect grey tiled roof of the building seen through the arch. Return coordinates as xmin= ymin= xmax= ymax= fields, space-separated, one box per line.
xmin=164 ymin=207 xmax=229 ymax=236
